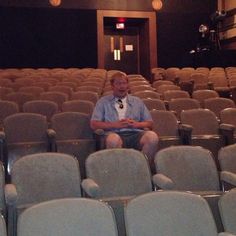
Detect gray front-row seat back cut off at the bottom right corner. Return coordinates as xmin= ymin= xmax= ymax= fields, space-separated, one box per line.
xmin=218 ymin=189 xmax=236 ymax=234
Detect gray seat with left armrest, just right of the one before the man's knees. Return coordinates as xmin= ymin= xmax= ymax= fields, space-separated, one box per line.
xmin=153 ymin=146 xmax=220 ymax=191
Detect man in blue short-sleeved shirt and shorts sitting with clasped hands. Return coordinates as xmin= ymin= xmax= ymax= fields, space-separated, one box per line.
xmin=90 ymin=72 xmax=158 ymax=172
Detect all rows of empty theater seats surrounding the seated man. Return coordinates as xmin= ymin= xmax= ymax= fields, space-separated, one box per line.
xmin=0 ymin=67 xmax=236 ymax=236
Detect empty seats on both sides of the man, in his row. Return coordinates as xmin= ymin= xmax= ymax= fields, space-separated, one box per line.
xmin=0 ymin=105 xmax=236 ymax=183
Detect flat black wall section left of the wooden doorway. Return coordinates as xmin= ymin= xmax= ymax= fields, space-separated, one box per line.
xmin=0 ymin=8 xmax=97 ymax=67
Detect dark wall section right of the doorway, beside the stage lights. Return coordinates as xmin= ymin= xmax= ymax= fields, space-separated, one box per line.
xmin=157 ymin=0 xmax=217 ymax=67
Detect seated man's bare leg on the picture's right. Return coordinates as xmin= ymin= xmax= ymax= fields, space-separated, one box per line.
xmin=140 ymin=130 xmax=158 ymax=173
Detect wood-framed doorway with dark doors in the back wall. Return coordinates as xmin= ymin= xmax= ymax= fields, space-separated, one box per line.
xmin=97 ymin=10 xmax=157 ymax=80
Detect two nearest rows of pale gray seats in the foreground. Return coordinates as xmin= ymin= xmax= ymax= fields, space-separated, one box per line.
xmin=0 ymin=144 xmax=236 ymax=235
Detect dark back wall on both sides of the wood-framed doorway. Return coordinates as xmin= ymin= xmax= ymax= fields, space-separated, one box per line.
xmin=0 ymin=0 xmax=217 ymax=68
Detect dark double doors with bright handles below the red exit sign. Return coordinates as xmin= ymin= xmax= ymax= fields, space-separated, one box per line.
xmin=104 ymin=27 xmax=140 ymax=74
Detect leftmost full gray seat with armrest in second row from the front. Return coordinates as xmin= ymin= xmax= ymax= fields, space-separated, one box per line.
xmin=5 ymin=153 xmax=81 ymax=236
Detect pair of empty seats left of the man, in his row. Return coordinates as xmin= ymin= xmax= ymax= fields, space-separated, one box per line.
xmin=0 ymin=112 xmax=96 ymax=180
